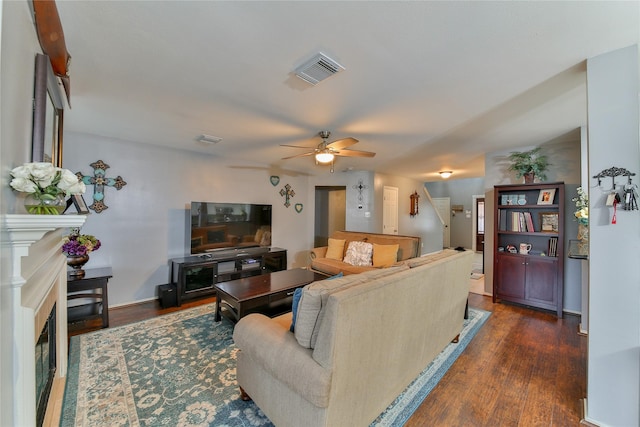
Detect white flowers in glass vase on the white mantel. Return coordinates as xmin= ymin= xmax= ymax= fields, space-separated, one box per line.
xmin=9 ymin=162 xmax=86 ymax=215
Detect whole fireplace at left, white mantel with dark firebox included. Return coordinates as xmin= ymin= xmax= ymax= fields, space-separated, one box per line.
xmin=0 ymin=215 xmax=86 ymax=426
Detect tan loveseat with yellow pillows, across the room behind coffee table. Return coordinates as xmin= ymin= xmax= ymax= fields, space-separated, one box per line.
xmin=309 ymin=231 xmax=421 ymax=275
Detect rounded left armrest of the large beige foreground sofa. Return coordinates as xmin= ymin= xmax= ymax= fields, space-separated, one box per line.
xmin=233 ymin=313 xmax=331 ymax=408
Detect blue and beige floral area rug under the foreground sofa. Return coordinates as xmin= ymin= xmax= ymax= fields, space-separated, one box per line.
xmin=60 ymin=304 xmax=490 ymax=427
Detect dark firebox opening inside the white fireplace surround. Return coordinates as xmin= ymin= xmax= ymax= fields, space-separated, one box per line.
xmin=35 ymin=304 xmax=57 ymax=426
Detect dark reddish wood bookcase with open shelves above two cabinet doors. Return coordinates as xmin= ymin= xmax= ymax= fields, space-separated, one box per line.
xmin=493 ymin=183 xmax=564 ymax=317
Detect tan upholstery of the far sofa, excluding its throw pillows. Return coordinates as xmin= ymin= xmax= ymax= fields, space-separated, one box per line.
xmin=309 ymin=231 xmax=421 ymax=275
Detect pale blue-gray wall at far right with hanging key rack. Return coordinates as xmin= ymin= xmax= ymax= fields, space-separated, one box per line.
xmin=587 ymin=45 xmax=640 ymax=426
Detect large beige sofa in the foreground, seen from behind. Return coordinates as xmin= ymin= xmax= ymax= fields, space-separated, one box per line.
xmin=233 ymin=250 xmax=473 ymax=427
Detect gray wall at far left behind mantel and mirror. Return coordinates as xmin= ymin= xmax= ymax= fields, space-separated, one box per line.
xmin=0 ymin=1 xmax=48 ymax=425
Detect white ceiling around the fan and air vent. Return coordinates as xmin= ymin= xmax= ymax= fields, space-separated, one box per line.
xmin=57 ymin=0 xmax=640 ymax=181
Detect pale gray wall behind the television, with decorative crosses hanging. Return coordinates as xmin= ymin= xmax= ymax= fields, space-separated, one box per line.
xmin=63 ymin=133 xmax=314 ymax=306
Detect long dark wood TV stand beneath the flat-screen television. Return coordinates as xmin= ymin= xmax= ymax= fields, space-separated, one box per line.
xmin=169 ymin=247 xmax=287 ymax=306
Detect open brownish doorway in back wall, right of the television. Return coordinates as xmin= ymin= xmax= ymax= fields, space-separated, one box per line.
xmin=313 ymin=186 xmax=347 ymax=248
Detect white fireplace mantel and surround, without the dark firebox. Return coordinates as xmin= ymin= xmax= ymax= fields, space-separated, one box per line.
xmin=1 ymin=215 xmax=87 ymax=426
